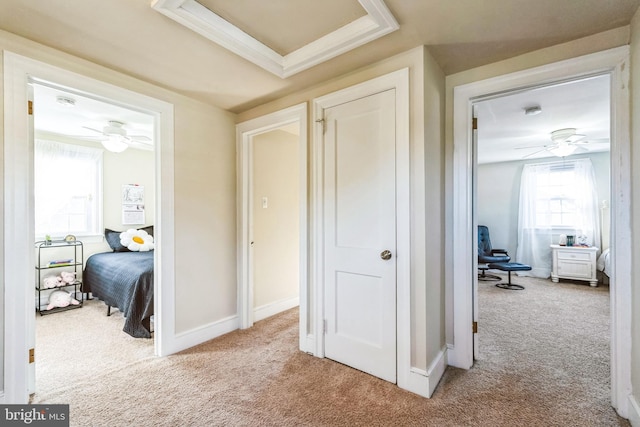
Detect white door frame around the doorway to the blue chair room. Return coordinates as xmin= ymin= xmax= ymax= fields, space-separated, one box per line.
xmin=446 ymin=46 xmax=631 ymax=417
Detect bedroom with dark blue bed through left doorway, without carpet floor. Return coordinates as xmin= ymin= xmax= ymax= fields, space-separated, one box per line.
xmin=34 ymin=84 xmax=155 ymax=339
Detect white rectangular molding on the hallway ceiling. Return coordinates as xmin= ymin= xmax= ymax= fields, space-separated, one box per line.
xmin=151 ymin=0 xmax=400 ymax=79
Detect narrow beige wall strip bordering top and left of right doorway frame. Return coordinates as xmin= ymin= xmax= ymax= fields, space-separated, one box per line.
xmin=445 ymin=27 xmax=630 ymax=343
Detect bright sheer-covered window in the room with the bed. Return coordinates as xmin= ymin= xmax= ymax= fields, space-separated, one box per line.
xmin=34 ymin=140 xmax=102 ymax=239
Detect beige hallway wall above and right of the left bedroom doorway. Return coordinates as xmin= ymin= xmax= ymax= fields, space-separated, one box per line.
xmin=0 ymin=31 xmax=237 ymax=350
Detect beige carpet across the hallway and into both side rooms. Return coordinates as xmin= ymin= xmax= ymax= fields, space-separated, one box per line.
xmin=33 ymin=278 xmax=629 ymax=427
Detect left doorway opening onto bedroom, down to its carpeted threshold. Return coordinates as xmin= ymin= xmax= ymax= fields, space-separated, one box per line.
xmin=31 ymin=80 xmax=161 ymax=395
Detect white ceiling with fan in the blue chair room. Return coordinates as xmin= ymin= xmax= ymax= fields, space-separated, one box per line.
xmin=477 ymin=75 xmax=611 ymax=164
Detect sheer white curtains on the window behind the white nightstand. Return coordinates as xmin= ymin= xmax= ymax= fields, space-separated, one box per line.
xmin=516 ymin=159 xmax=600 ymax=278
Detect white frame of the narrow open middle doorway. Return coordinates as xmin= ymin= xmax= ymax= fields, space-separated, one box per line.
xmin=236 ymin=103 xmax=309 ymax=351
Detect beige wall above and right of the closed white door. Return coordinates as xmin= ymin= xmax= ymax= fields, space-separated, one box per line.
xmin=237 ymin=46 xmax=444 ymax=370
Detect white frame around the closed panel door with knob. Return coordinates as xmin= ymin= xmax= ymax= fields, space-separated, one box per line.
xmin=309 ymin=68 xmax=424 ymax=397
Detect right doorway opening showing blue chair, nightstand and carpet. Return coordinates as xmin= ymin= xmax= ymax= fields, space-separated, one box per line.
xmin=473 ymin=73 xmax=611 ymax=406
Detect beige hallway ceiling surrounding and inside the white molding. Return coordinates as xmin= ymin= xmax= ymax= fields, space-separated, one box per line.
xmin=0 ymin=0 xmax=640 ymax=112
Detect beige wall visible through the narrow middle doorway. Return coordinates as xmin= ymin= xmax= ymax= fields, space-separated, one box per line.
xmin=252 ymin=129 xmax=300 ymax=308
